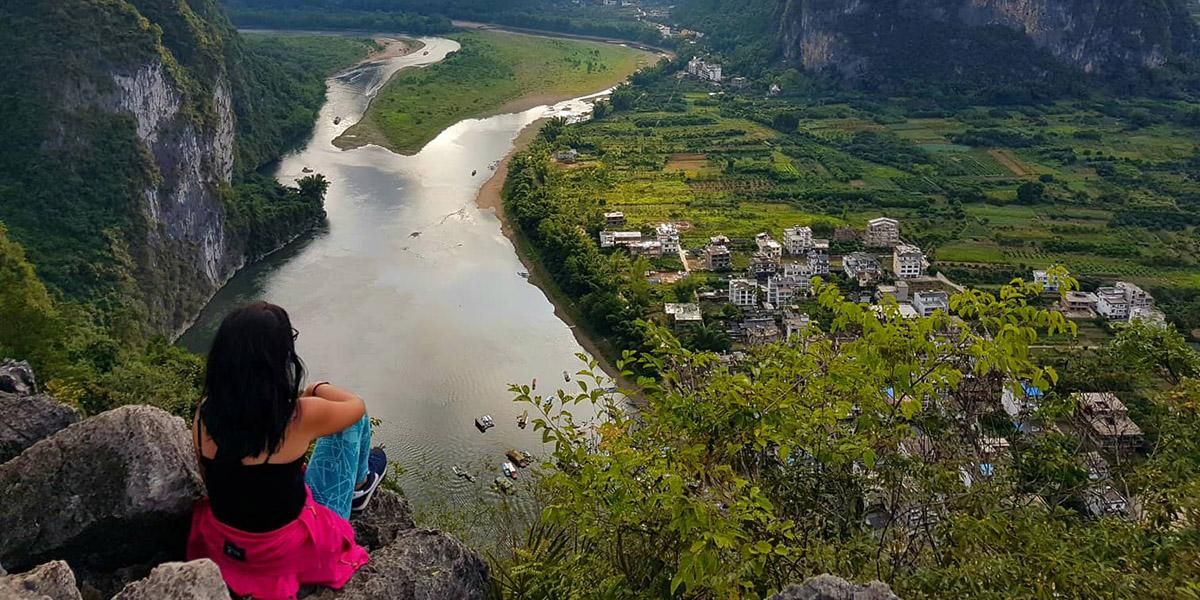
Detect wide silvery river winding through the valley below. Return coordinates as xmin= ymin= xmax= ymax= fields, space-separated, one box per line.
xmin=181 ymin=38 xmax=609 ymax=520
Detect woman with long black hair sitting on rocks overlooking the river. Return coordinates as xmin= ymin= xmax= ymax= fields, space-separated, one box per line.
xmin=187 ymin=302 xmax=388 ymax=600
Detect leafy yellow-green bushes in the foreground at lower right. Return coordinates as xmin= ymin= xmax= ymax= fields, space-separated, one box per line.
xmin=498 ymin=282 xmax=1200 ymax=599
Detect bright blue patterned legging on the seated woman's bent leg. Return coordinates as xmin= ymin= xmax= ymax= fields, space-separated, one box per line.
xmin=305 ymin=415 xmax=371 ymax=518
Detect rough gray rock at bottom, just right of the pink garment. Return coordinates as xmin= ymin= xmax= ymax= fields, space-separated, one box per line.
xmin=311 ymin=529 xmax=488 ymax=600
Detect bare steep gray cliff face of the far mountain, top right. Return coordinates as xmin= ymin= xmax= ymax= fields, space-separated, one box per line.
xmin=779 ymin=0 xmax=1198 ymax=74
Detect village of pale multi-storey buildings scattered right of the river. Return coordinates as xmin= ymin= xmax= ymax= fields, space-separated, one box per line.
xmin=599 ymin=211 xmax=1164 ymax=527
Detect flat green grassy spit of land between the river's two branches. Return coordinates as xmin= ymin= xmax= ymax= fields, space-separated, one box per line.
xmin=334 ymin=30 xmax=656 ymax=155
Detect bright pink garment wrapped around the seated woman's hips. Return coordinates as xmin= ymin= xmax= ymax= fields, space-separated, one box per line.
xmin=187 ymin=491 xmax=368 ymax=600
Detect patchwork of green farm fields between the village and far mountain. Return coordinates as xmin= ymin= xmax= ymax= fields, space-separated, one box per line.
xmin=535 ymin=79 xmax=1200 ymax=331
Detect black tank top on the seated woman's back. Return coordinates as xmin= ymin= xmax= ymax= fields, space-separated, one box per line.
xmin=200 ymin=456 xmax=308 ymax=533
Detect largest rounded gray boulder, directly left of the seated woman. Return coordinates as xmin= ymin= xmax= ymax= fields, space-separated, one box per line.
xmin=0 ymin=406 xmax=203 ymax=571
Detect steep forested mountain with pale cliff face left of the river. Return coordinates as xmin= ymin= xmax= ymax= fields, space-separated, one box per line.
xmin=0 ymin=0 xmax=333 ymax=334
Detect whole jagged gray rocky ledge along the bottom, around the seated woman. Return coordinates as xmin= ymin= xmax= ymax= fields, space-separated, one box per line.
xmin=0 ymin=362 xmax=896 ymax=600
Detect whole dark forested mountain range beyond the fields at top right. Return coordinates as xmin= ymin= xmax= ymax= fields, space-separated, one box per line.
xmin=676 ymin=0 xmax=1200 ymax=97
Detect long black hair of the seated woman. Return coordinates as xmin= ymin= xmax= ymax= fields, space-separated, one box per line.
xmin=200 ymin=302 xmax=304 ymax=461
